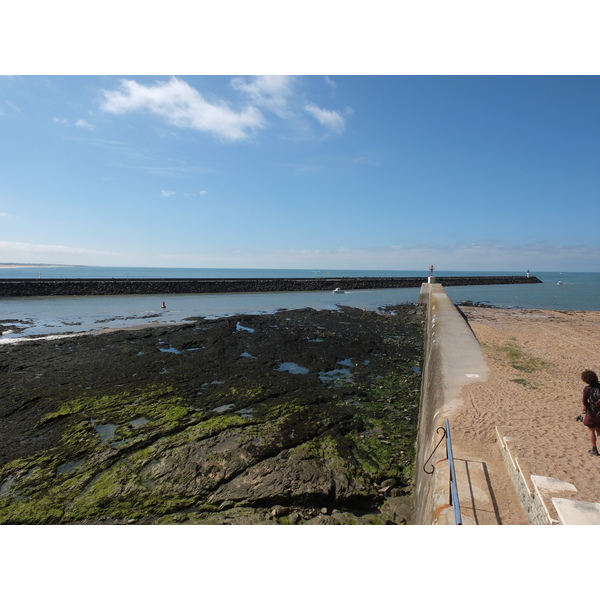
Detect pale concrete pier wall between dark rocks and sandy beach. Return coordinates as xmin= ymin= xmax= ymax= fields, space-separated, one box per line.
xmin=415 ymin=283 xmax=488 ymax=525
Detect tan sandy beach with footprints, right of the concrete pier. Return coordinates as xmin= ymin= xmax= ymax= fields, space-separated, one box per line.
xmin=451 ymin=307 xmax=600 ymax=524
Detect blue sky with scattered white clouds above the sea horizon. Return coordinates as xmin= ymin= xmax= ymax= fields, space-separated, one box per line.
xmin=0 ymin=75 xmax=600 ymax=272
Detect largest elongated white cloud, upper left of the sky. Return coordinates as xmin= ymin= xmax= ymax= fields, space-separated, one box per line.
xmin=102 ymin=77 xmax=264 ymax=141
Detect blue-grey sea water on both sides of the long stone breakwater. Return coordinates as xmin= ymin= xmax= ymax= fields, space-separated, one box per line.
xmin=0 ymin=266 xmax=600 ymax=344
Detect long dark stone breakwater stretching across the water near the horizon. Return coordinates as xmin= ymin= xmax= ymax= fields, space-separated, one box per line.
xmin=0 ymin=276 xmax=541 ymax=297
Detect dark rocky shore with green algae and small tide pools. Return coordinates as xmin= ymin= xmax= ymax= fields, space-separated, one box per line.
xmin=0 ymin=305 xmax=424 ymax=524
